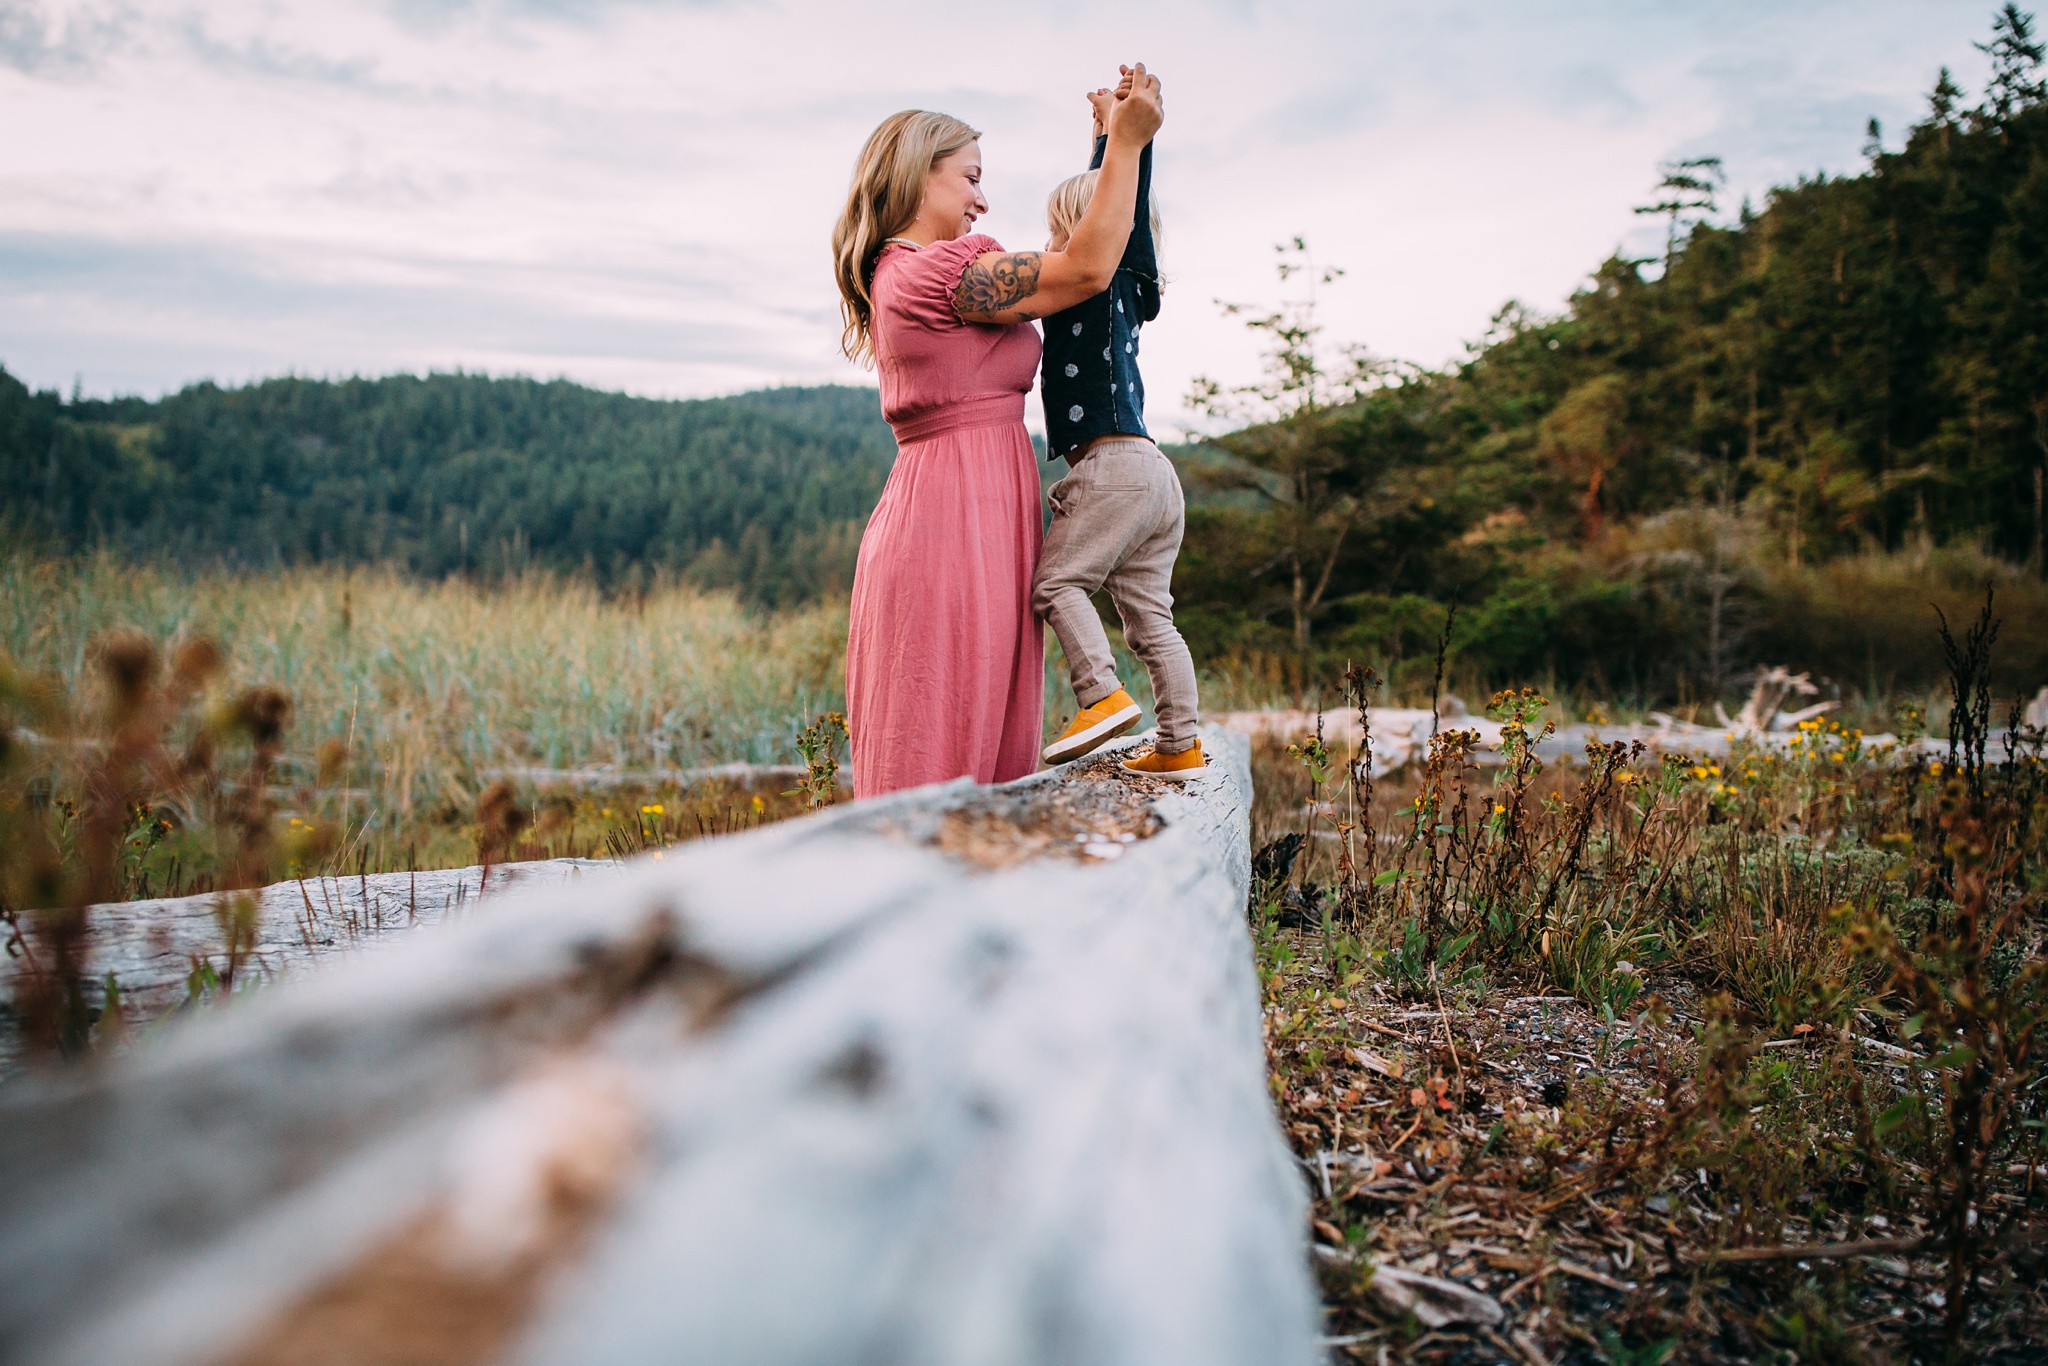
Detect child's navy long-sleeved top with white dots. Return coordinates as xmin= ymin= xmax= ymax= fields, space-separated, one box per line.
xmin=1038 ymin=137 xmax=1159 ymax=459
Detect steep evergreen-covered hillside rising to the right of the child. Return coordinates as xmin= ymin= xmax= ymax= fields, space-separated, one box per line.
xmin=1180 ymin=6 xmax=2048 ymax=696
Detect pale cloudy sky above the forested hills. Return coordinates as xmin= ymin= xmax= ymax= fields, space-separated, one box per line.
xmin=0 ymin=0 xmax=1993 ymax=434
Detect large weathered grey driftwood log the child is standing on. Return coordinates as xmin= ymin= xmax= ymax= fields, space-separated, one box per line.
xmin=0 ymin=735 xmax=1317 ymax=1366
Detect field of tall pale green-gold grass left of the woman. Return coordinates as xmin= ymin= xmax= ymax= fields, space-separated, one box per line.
xmin=0 ymin=551 xmax=846 ymax=819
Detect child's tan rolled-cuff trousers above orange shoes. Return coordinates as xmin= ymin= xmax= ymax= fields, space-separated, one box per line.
xmin=1032 ymin=436 xmax=1196 ymax=754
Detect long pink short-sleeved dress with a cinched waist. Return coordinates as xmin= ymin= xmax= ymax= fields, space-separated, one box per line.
xmin=846 ymin=233 xmax=1044 ymax=797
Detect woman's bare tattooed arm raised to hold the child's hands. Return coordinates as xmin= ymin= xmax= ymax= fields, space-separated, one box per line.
xmin=952 ymin=61 xmax=1165 ymax=324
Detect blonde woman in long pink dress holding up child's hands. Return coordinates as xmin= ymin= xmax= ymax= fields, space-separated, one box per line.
xmin=831 ymin=66 xmax=1163 ymax=797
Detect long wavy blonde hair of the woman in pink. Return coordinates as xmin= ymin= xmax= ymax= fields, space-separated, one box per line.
xmin=831 ymin=109 xmax=981 ymax=362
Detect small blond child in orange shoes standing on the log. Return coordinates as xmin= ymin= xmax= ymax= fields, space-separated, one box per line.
xmin=1032 ymin=90 xmax=1206 ymax=780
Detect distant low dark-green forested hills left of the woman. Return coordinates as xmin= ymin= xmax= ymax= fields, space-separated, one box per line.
xmin=0 ymin=371 xmax=895 ymax=604
